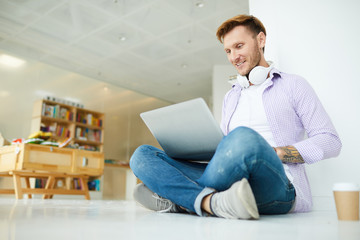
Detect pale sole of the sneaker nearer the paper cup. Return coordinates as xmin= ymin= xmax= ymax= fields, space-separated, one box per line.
xmin=237 ymin=178 xmax=259 ymax=219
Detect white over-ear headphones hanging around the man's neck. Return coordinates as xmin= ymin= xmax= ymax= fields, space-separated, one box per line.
xmin=236 ymin=61 xmax=274 ymax=88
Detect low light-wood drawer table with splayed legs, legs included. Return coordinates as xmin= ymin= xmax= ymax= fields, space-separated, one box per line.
xmin=0 ymin=143 xmax=104 ymax=199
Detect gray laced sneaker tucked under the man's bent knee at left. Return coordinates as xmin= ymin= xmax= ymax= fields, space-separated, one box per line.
xmin=134 ymin=183 xmax=180 ymax=213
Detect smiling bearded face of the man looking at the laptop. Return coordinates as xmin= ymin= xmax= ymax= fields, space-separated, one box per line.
xmin=223 ymin=26 xmax=266 ymax=76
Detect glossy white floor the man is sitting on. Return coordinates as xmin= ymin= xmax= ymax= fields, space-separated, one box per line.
xmin=0 ymin=198 xmax=360 ymax=240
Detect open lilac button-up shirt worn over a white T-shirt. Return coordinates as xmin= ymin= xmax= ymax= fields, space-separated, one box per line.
xmin=221 ymin=69 xmax=342 ymax=212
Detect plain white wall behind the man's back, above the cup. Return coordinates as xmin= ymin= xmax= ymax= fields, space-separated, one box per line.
xmin=249 ymin=0 xmax=360 ymax=199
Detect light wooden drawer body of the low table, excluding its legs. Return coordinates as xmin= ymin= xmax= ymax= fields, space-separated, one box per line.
xmin=0 ymin=143 xmax=104 ymax=177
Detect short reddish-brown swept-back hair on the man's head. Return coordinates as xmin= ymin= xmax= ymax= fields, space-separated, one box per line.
xmin=216 ymin=14 xmax=266 ymax=43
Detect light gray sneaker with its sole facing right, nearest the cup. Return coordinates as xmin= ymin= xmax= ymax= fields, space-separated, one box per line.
xmin=210 ymin=178 xmax=259 ymax=219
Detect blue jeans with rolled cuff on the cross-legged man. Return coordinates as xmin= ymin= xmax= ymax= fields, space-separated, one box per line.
xmin=130 ymin=127 xmax=295 ymax=215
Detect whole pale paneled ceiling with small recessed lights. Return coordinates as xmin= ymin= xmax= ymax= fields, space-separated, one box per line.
xmin=0 ymin=0 xmax=248 ymax=102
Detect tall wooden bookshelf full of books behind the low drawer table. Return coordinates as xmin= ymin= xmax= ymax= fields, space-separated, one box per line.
xmin=31 ymin=99 xmax=105 ymax=198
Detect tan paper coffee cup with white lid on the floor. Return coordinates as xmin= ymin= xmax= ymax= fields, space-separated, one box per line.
xmin=333 ymin=183 xmax=360 ymax=221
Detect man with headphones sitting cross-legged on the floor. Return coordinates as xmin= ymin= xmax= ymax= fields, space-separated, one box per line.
xmin=130 ymin=15 xmax=342 ymax=219
